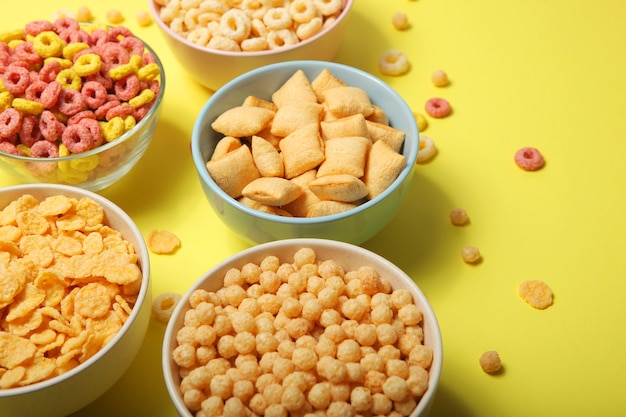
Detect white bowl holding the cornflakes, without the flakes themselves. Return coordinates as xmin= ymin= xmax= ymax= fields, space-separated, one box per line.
xmin=0 ymin=184 xmax=151 ymax=417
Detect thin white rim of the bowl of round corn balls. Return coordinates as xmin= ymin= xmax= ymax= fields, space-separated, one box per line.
xmin=161 ymin=238 xmax=443 ymax=416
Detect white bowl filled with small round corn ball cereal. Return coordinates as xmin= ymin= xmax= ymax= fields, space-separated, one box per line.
xmin=163 ymin=239 xmax=442 ymax=417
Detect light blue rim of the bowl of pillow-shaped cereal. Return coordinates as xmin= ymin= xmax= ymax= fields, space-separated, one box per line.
xmin=191 ymin=60 xmax=419 ymax=225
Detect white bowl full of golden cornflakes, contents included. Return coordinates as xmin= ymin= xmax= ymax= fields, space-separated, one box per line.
xmin=0 ymin=184 xmax=150 ymax=417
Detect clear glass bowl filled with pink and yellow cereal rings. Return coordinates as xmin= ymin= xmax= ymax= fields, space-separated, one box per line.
xmin=0 ymin=18 xmax=165 ymax=191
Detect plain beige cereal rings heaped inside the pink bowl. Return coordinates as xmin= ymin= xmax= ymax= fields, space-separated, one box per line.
xmin=155 ymin=0 xmax=344 ymax=52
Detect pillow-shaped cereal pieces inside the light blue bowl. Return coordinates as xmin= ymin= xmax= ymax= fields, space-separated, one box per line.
xmin=206 ymin=70 xmax=406 ymax=217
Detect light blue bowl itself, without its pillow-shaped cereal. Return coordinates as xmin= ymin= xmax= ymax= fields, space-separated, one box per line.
xmin=191 ymin=61 xmax=419 ymax=245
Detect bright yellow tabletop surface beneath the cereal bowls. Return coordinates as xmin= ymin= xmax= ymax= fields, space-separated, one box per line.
xmin=0 ymin=0 xmax=626 ymax=417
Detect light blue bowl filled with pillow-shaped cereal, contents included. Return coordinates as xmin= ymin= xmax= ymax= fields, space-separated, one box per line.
xmin=191 ymin=60 xmax=419 ymax=244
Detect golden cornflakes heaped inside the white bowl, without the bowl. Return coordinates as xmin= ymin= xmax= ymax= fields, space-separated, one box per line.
xmin=0 ymin=194 xmax=142 ymax=389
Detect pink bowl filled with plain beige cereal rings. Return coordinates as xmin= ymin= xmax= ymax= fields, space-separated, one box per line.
xmin=149 ymin=0 xmax=354 ymax=91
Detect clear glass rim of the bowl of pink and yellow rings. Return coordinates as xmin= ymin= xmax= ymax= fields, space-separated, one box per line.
xmin=0 ymin=37 xmax=165 ymax=163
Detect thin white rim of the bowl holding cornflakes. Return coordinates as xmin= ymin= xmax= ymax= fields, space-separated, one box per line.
xmin=0 ymin=184 xmax=150 ymax=398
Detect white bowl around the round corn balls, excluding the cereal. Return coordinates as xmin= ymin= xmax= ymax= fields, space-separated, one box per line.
xmin=162 ymin=238 xmax=443 ymax=417
